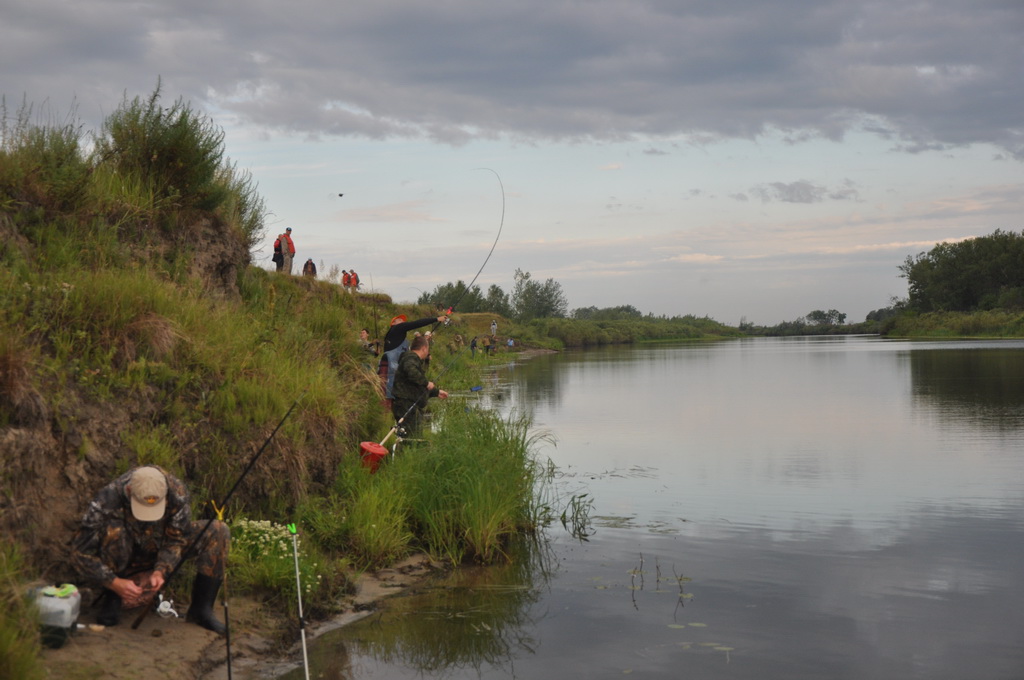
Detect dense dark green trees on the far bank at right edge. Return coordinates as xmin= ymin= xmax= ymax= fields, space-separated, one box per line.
xmin=899 ymin=229 xmax=1024 ymax=311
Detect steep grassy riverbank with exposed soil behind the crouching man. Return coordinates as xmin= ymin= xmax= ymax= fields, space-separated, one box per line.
xmin=0 ymin=90 xmax=546 ymax=678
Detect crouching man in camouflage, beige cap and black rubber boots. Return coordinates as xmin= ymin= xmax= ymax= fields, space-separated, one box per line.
xmin=70 ymin=465 xmax=230 ymax=635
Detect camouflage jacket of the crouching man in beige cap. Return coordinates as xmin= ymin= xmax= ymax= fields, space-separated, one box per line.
xmin=71 ymin=468 xmax=191 ymax=586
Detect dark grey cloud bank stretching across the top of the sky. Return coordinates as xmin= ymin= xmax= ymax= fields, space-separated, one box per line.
xmin=0 ymin=0 xmax=1024 ymax=158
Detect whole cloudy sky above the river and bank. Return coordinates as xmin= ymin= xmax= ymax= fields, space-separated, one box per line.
xmin=0 ymin=0 xmax=1024 ymax=324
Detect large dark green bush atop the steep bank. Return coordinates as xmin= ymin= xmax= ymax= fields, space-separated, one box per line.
xmin=96 ymin=83 xmax=228 ymax=215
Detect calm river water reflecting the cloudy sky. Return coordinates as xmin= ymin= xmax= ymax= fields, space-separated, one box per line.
xmin=288 ymin=337 xmax=1024 ymax=680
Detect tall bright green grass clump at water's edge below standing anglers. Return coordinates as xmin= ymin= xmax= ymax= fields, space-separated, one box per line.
xmin=319 ymin=407 xmax=547 ymax=567
